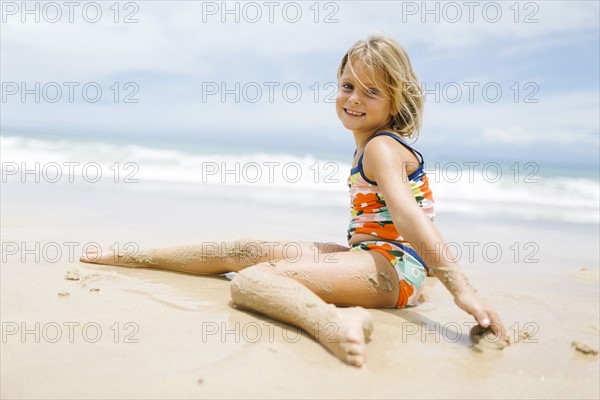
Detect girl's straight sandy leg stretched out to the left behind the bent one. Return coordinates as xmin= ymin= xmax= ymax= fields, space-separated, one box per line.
xmin=80 ymin=239 xmax=347 ymax=275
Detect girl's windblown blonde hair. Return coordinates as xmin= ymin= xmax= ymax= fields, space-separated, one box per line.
xmin=337 ymin=35 xmax=423 ymax=138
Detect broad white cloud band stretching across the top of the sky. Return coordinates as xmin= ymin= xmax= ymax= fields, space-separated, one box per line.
xmin=1 ymin=1 xmax=598 ymax=81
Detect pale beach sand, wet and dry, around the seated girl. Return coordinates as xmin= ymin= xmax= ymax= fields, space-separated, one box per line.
xmin=0 ymin=183 xmax=600 ymax=398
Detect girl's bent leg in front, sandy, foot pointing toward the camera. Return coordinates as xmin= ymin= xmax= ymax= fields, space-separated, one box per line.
xmin=231 ymin=251 xmax=399 ymax=366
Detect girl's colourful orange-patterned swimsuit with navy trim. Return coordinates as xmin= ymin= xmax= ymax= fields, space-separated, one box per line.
xmin=348 ymin=132 xmax=435 ymax=308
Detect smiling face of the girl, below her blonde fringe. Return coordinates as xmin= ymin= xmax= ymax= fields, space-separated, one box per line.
xmin=336 ymin=63 xmax=393 ymax=137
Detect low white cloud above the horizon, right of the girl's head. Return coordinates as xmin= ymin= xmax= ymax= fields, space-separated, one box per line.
xmin=425 ymin=90 xmax=600 ymax=145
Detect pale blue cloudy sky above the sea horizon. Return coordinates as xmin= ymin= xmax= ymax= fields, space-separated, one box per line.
xmin=0 ymin=1 xmax=600 ymax=166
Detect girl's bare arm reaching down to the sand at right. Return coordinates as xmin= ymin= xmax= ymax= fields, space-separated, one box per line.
xmin=363 ymin=136 xmax=506 ymax=337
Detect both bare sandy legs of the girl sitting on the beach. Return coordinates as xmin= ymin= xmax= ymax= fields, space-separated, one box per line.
xmin=80 ymin=240 xmax=399 ymax=366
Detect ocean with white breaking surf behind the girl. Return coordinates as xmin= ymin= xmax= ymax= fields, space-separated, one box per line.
xmin=0 ymin=134 xmax=600 ymax=224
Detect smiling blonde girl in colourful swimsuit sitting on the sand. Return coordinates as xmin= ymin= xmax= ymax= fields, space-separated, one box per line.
xmin=81 ymin=36 xmax=505 ymax=366
